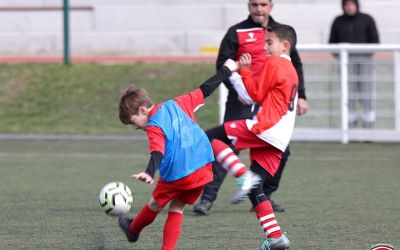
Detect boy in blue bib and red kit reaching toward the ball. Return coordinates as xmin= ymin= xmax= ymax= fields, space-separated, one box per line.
xmin=118 ymin=60 xmax=258 ymax=250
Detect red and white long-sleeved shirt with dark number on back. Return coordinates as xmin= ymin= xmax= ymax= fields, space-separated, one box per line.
xmin=240 ymin=55 xmax=299 ymax=151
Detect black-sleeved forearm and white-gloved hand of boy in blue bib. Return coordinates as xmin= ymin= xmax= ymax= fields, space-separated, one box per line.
xmin=200 ymin=59 xmax=238 ymax=98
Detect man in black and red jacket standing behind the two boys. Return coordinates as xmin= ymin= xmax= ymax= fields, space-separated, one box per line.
xmin=193 ymin=0 xmax=308 ymax=215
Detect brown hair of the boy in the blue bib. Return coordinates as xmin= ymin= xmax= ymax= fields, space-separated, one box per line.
xmin=119 ymin=87 xmax=153 ymax=124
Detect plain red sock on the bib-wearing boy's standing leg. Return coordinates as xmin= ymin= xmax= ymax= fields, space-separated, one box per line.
xmin=161 ymin=212 xmax=182 ymax=250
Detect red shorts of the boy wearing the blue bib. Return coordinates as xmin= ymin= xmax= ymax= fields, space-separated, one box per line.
xmin=153 ymin=163 xmax=213 ymax=207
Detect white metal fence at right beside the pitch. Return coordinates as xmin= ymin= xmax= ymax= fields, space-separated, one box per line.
xmin=219 ymin=44 xmax=400 ymax=143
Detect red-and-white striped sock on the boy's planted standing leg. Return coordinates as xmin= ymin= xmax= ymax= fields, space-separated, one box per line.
xmin=254 ymin=200 xmax=282 ymax=238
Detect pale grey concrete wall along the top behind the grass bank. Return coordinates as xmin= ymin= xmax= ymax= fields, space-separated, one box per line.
xmin=0 ymin=0 xmax=400 ymax=55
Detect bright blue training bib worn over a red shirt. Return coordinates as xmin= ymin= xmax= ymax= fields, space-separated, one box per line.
xmin=147 ymin=100 xmax=214 ymax=182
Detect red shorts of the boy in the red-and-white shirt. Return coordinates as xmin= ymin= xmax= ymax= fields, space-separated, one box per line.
xmin=224 ymin=120 xmax=282 ymax=176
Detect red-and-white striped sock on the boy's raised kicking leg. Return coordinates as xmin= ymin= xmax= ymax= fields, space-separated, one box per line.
xmin=211 ymin=139 xmax=247 ymax=178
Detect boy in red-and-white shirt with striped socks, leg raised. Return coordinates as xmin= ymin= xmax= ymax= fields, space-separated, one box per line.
xmin=207 ymin=25 xmax=299 ymax=250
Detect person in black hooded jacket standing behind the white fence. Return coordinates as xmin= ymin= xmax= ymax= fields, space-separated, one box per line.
xmin=329 ymin=0 xmax=379 ymax=128
